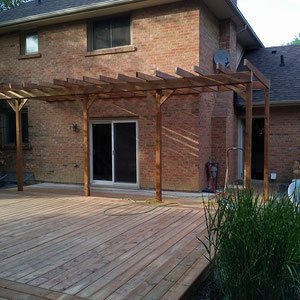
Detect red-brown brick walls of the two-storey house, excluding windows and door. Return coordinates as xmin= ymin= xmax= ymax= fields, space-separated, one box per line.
xmin=0 ymin=0 xmax=241 ymax=191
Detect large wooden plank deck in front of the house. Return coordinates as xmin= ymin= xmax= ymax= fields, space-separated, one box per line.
xmin=0 ymin=190 xmax=208 ymax=300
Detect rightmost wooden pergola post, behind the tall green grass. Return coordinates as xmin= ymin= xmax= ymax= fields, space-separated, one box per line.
xmin=264 ymin=88 xmax=270 ymax=201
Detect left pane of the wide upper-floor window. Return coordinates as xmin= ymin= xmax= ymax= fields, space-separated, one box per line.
xmin=93 ymin=20 xmax=111 ymax=50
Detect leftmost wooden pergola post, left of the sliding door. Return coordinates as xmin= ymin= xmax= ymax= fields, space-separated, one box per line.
xmin=15 ymin=100 xmax=24 ymax=191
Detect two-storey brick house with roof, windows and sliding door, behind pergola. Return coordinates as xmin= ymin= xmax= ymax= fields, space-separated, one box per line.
xmin=0 ymin=0 xmax=299 ymax=191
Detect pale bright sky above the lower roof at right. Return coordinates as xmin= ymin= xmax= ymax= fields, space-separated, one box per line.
xmin=238 ymin=0 xmax=300 ymax=47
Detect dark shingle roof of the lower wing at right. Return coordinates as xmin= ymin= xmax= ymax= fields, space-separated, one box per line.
xmin=239 ymin=45 xmax=300 ymax=102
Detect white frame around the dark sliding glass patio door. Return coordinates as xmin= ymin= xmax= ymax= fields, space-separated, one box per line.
xmin=90 ymin=119 xmax=140 ymax=188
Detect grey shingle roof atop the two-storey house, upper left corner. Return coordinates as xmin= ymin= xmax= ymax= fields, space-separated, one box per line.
xmin=0 ymin=0 xmax=117 ymax=22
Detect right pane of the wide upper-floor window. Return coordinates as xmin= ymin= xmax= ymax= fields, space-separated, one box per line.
xmin=112 ymin=18 xmax=130 ymax=47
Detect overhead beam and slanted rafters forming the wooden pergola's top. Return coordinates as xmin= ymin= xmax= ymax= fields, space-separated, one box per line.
xmin=0 ymin=71 xmax=250 ymax=99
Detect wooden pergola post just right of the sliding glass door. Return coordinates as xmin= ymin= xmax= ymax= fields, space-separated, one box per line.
xmin=155 ymin=91 xmax=162 ymax=202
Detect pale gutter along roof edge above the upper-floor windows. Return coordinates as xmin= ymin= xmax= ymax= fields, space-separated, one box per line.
xmin=0 ymin=0 xmax=148 ymax=28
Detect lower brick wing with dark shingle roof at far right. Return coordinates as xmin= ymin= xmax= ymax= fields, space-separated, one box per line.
xmin=236 ymin=45 xmax=300 ymax=182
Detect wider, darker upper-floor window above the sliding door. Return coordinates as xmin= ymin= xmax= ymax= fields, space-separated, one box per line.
xmin=89 ymin=16 xmax=131 ymax=50
